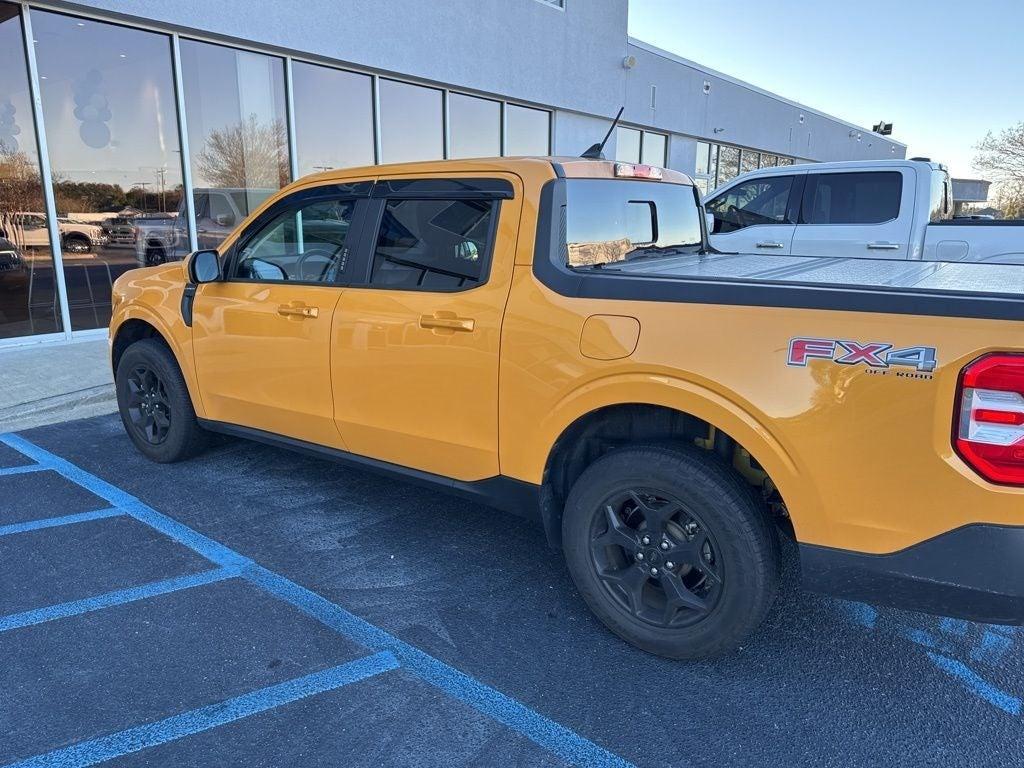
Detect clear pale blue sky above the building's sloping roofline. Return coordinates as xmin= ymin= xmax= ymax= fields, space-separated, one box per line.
xmin=630 ymin=0 xmax=1024 ymax=176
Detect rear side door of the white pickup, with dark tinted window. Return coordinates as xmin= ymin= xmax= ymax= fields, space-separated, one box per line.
xmin=793 ymin=168 xmax=916 ymax=259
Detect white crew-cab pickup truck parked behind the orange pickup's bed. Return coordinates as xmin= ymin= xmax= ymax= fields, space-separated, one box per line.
xmin=705 ymin=160 xmax=1024 ymax=264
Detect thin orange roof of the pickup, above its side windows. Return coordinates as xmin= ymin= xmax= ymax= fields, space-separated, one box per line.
xmin=301 ymin=156 xmax=693 ymax=186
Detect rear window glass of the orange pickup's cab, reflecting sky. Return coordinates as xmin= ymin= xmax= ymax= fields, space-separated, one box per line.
xmin=565 ymin=179 xmax=702 ymax=267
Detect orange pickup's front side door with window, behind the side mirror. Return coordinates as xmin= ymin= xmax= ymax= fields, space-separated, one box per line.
xmin=193 ymin=182 xmax=371 ymax=447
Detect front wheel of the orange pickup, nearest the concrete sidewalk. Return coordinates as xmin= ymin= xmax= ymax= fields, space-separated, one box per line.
xmin=115 ymin=339 xmax=209 ymax=464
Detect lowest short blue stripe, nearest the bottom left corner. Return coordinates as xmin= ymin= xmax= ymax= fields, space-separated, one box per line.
xmin=7 ymin=653 xmax=398 ymax=768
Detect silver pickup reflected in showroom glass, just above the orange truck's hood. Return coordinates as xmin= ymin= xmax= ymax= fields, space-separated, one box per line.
xmin=135 ymin=187 xmax=274 ymax=266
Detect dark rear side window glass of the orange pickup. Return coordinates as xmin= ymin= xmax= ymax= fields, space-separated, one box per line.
xmin=370 ymin=199 xmax=498 ymax=291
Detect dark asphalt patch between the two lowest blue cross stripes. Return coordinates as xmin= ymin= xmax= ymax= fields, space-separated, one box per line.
xmin=0 ymin=580 xmax=365 ymax=761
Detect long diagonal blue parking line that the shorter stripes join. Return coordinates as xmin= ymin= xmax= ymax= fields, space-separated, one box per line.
xmin=0 ymin=434 xmax=633 ymax=768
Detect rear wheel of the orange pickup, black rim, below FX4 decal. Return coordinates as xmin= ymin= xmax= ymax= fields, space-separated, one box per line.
xmin=562 ymin=446 xmax=779 ymax=659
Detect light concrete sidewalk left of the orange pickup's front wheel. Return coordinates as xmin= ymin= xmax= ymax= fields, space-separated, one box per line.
xmin=0 ymin=339 xmax=118 ymax=432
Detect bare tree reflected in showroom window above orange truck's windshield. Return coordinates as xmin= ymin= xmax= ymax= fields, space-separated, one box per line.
xmin=196 ymin=115 xmax=291 ymax=189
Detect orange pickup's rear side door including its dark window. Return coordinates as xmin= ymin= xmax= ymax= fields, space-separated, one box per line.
xmin=331 ymin=177 xmax=522 ymax=480
